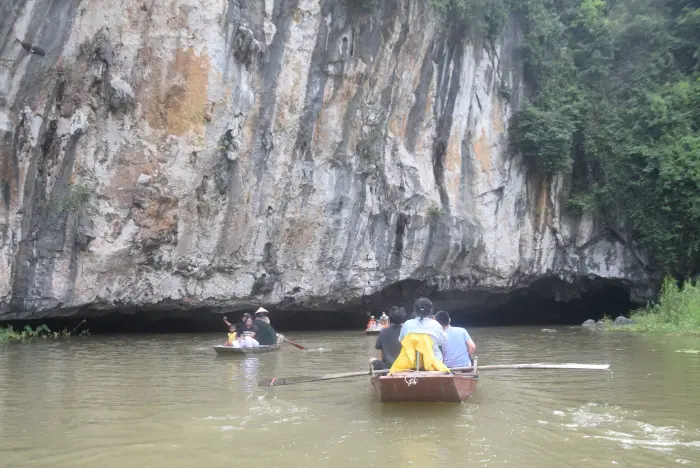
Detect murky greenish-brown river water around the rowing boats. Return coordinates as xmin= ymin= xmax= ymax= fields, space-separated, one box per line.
xmin=0 ymin=327 xmax=700 ymax=468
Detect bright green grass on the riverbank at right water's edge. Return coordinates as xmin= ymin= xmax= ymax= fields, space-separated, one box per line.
xmin=605 ymin=277 xmax=700 ymax=336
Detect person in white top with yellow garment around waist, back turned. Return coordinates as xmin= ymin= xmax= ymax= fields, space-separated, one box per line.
xmin=389 ymin=297 xmax=450 ymax=374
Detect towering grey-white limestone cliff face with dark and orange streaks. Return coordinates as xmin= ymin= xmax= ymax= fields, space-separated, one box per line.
xmin=0 ymin=0 xmax=649 ymax=319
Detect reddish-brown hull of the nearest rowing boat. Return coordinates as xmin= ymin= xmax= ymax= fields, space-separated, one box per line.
xmin=370 ymin=371 xmax=479 ymax=403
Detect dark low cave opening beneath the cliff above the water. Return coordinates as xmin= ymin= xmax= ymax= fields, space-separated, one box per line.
xmin=0 ymin=278 xmax=637 ymax=334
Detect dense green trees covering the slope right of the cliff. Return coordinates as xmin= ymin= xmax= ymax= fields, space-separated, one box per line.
xmin=510 ymin=0 xmax=700 ymax=278
